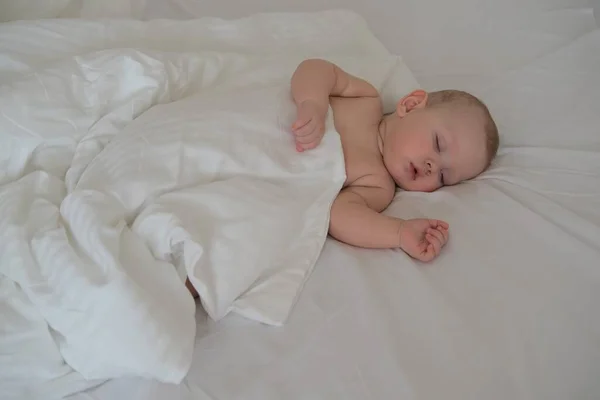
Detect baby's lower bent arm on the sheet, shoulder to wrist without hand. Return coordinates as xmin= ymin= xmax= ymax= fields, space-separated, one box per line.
xmin=329 ymin=179 xmax=403 ymax=248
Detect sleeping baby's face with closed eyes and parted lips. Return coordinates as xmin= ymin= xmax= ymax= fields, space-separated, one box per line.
xmin=383 ymin=107 xmax=486 ymax=192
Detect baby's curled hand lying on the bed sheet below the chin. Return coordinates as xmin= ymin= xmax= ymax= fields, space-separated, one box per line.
xmin=400 ymin=219 xmax=449 ymax=261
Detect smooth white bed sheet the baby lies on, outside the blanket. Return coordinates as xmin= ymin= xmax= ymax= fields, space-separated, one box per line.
xmin=0 ymin=0 xmax=600 ymax=400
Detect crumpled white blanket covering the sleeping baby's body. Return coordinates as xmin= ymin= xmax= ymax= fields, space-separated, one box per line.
xmin=0 ymin=12 xmax=416 ymax=398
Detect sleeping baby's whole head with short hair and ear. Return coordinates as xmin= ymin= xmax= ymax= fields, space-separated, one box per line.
xmin=379 ymin=90 xmax=499 ymax=192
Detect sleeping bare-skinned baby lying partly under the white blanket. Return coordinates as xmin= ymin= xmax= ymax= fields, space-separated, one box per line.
xmin=186 ymin=59 xmax=498 ymax=297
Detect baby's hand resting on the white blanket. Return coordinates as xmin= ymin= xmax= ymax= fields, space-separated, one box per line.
xmin=292 ymin=100 xmax=327 ymax=151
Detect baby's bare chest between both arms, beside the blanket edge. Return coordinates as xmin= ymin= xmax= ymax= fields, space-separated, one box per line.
xmin=331 ymin=97 xmax=391 ymax=187
